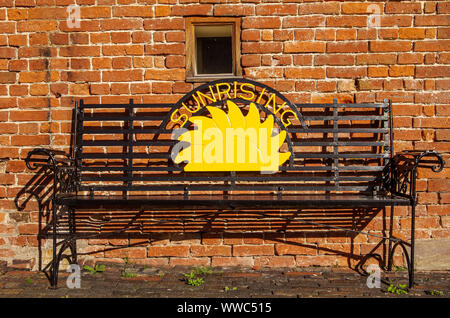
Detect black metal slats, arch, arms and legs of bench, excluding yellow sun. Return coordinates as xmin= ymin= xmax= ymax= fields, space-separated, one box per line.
xmin=26 ymin=79 xmax=443 ymax=287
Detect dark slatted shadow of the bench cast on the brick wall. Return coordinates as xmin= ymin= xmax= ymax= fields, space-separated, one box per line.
xmin=15 ymin=175 xmax=389 ymax=275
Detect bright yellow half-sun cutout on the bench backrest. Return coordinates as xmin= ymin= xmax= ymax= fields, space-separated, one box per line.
xmin=174 ymin=101 xmax=291 ymax=171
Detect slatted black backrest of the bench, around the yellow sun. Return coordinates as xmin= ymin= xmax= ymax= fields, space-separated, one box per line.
xmin=74 ymin=79 xmax=392 ymax=194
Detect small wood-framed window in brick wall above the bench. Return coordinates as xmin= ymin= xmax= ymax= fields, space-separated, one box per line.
xmin=186 ymin=17 xmax=242 ymax=82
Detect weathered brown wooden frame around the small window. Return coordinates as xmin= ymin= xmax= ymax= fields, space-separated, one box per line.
xmin=186 ymin=17 xmax=242 ymax=82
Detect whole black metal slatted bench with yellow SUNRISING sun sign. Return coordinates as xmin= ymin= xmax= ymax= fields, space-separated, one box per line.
xmin=26 ymin=79 xmax=443 ymax=287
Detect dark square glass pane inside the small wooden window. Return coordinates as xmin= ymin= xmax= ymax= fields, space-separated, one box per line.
xmin=197 ymin=37 xmax=233 ymax=74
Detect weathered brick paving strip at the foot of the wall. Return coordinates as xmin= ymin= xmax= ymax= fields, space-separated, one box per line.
xmin=0 ymin=265 xmax=450 ymax=298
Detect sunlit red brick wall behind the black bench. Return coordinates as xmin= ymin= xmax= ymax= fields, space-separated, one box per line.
xmin=0 ymin=0 xmax=450 ymax=268
